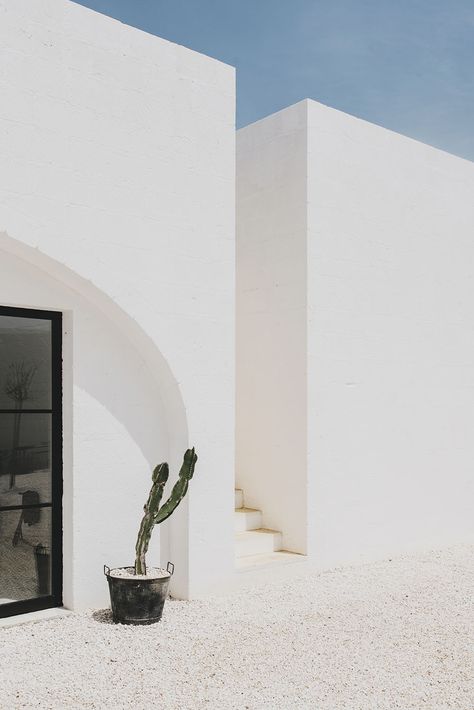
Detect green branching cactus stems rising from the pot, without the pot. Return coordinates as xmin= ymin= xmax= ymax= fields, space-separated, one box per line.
xmin=135 ymin=448 xmax=197 ymax=574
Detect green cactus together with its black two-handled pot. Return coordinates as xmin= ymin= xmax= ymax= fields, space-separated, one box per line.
xmin=104 ymin=448 xmax=197 ymax=624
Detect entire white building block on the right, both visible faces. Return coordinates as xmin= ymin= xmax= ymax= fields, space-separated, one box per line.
xmin=237 ymin=101 xmax=474 ymax=566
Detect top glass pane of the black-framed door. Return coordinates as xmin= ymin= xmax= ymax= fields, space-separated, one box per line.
xmin=0 ymin=316 xmax=51 ymax=409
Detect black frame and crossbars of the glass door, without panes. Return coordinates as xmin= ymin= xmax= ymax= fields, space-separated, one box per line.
xmin=0 ymin=305 xmax=63 ymax=618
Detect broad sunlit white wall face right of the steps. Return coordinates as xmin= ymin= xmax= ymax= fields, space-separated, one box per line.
xmin=307 ymin=101 xmax=474 ymax=565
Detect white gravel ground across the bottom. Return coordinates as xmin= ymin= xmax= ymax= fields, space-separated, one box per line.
xmin=0 ymin=546 xmax=474 ymax=710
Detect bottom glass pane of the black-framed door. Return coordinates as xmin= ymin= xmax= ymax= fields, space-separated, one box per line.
xmin=0 ymin=508 xmax=51 ymax=605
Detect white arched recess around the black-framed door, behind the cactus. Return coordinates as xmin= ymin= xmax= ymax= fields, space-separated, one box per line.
xmin=0 ymin=233 xmax=187 ymax=608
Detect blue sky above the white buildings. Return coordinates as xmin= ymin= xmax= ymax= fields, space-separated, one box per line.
xmin=74 ymin=0 xmax=474 ymax=160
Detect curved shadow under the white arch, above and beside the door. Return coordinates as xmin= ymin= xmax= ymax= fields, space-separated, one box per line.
xmin=0 ymin=233 xmax=187 ymax=466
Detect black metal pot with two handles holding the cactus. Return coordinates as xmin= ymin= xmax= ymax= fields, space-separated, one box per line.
xmin=104 ymin=562 xmax=174 ymax=625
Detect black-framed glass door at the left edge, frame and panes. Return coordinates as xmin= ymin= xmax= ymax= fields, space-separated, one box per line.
xmin=0 ymin=306 xmax=63 ymax=618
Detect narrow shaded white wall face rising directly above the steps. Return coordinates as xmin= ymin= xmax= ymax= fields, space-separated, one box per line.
xmin=236 ymin=104 xmax=307 ymax=553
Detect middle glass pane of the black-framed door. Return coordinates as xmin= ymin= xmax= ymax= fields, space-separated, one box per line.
xmin=0 ymin=412 xmax=51 ymax=508
